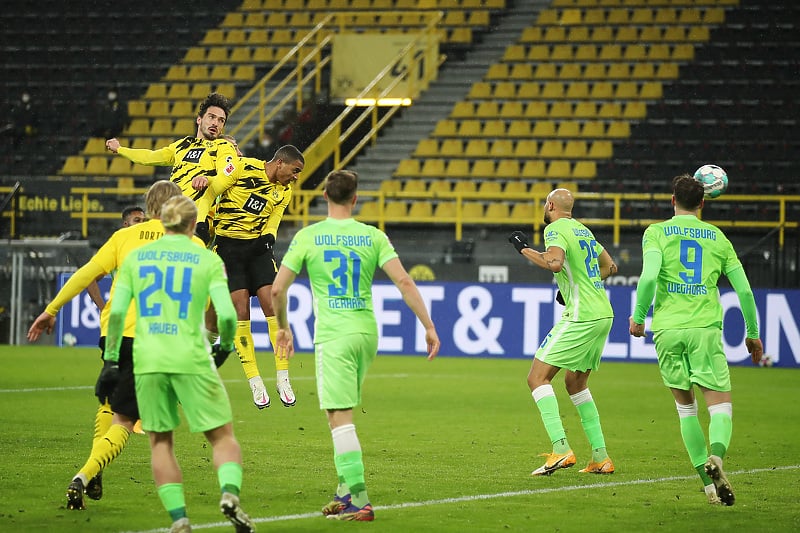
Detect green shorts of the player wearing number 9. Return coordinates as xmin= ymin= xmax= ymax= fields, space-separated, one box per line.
xmin=653 ymin=327 xmax=731 ymax=392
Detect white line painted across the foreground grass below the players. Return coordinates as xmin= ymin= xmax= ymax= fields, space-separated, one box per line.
xmin=120 ymin=465 xmax=800 ymax=533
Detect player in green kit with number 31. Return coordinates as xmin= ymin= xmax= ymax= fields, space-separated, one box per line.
xmin=272 ymin=170 xmax=440 ymax=521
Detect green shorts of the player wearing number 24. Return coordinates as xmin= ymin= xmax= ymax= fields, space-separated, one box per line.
xmin=136 ymin=369 xmax=233 ymax=433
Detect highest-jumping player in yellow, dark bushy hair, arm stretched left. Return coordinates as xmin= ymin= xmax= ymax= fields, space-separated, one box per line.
xmin=106 ymin=93 xmax=240 ymax=235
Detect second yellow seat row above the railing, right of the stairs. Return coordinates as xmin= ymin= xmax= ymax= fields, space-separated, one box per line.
xmin=413 ymin=138 xmax=612 ymax=159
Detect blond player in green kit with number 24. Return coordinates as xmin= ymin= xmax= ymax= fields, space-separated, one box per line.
xmin=102 ymin=196 xmax=255 ymax=532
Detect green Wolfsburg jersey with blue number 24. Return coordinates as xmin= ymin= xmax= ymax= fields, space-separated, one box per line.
xmin=112 ymin=235 xmax=228 ymax=374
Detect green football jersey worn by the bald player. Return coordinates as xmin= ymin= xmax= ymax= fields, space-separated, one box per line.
xmin=544 ymin=218 xmax=614 ymax=322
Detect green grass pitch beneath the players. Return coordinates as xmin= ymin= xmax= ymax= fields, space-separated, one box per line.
xmin=0 ymin=346 xmax=800 ymax=533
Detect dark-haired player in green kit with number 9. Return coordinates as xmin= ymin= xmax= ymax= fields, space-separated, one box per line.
xmin=630 ymin=174 xmax=764 ymax=505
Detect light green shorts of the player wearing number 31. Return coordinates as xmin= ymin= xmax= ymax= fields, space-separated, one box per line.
xmin=314 ymin=333 xmax=378 ymax=409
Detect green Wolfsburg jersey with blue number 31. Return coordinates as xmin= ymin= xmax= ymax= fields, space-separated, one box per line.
xmin=282 ymin=218 xmax=397 ymax=343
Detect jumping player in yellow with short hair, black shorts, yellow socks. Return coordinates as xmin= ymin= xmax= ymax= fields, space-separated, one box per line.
xmin=206 ymin=137 xmax=305 ymax=409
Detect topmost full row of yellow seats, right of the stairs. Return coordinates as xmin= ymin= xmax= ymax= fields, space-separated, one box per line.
xmin=537 ymin=6 xmax=725 ymax=25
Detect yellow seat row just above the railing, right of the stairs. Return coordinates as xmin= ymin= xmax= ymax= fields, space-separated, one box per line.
xmin=392 ymin=158 xmax=597 ymax=180
